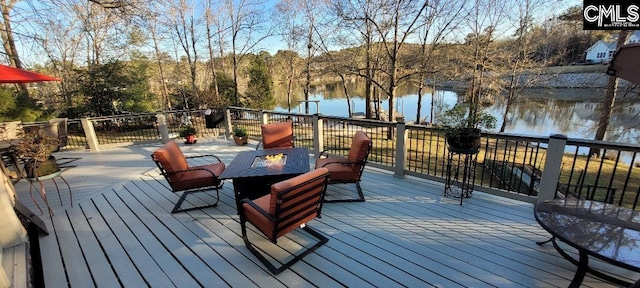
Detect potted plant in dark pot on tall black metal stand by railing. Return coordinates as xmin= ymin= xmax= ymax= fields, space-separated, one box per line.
xmin=438 ymin=103 xmax=497 ymax=150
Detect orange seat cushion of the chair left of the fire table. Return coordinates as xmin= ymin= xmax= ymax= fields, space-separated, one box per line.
xmin=171 ymin=163 xmax=225 ymax=191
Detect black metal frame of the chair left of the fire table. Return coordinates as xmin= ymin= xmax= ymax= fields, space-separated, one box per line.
xmin=151 ymin=154 xmax=224 ymax=213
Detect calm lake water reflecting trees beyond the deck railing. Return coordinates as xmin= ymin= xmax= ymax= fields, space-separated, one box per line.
xmin=275 ymin=81 xmax=640 ymax=144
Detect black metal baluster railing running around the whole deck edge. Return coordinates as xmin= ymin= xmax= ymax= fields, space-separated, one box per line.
xmin=8 ymin=107 xmax=640 ymax=209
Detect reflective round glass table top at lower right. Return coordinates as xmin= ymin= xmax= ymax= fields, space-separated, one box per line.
xmin=535 ymin=199 xmax=640 ymax=271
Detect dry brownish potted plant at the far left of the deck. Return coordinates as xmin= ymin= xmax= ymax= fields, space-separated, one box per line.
xmin=12 ymin=129 xmax=60 ymax=178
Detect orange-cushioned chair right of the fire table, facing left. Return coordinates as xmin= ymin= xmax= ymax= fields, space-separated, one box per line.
xmin=316 ymin=131 xmax=371 ymax=202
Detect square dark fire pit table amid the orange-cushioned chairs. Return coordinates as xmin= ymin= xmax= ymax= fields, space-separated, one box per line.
xmin=218 ymin=148 xmax=309 ymax=211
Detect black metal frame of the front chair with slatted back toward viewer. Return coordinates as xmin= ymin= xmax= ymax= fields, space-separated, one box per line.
xmin=238 ymin=173 xmax=329 ymax=275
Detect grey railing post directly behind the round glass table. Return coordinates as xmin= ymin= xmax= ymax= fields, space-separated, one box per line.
xmin=537 ymin=134 xmax=567 ymax=203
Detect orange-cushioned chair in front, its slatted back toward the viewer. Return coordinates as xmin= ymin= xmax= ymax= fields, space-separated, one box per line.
xmin=239 ymin=168 xmax=329 ymax=274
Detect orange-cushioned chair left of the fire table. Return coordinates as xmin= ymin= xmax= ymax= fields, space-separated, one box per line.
xmin=151 ymin=141 xmax=225 ymax=213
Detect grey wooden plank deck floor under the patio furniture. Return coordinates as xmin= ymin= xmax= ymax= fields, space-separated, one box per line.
xmin=11 ymin=140 xmax=640 ymax=287
